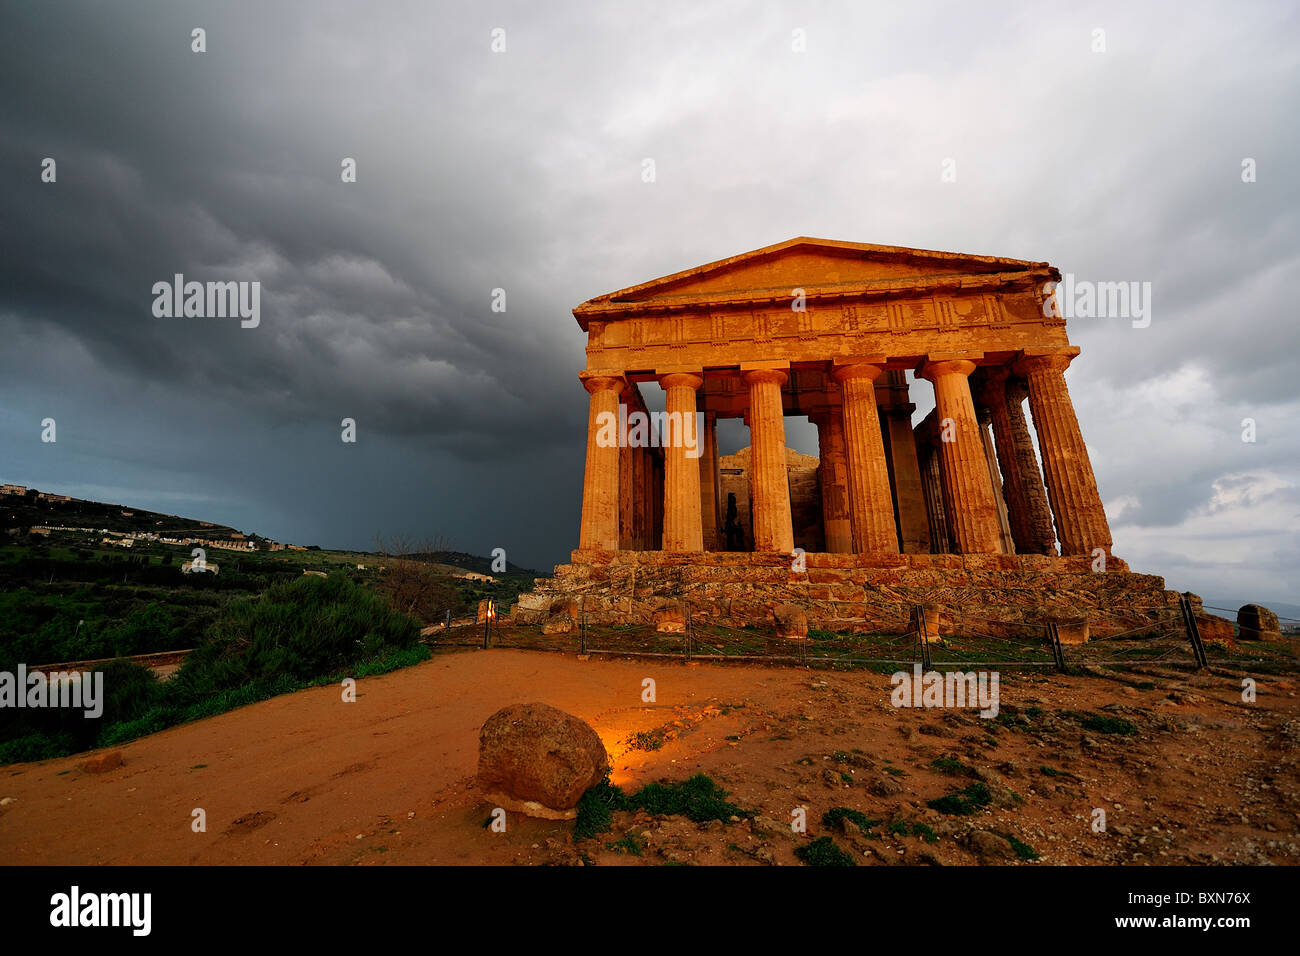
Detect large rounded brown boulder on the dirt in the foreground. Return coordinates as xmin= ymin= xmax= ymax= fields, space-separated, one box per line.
xmin=478 ymin=704 xmax=610 ymax=819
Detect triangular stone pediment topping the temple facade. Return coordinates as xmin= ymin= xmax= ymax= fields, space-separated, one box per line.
xmin=573 ymin=237 xmax=1050 ymax=323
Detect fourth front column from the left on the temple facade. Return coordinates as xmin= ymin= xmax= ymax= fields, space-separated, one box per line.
xmin=832 ymin=356 xmax=898 ymax=554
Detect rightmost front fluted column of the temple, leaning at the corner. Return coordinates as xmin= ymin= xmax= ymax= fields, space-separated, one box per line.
xmin=1015 ymin=346 xmax=1110 ymax=555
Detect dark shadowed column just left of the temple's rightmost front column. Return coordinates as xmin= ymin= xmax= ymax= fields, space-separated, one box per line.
xmin=979 ymin=368 xmax=1056 ymax=554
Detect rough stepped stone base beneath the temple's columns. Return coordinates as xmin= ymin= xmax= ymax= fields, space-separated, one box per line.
xmin=511 ymin=550 xmax=1206 ymax=639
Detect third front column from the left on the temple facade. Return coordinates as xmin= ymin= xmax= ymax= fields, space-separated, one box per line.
xmin=742 ymin=368 xmax=794 ymax=554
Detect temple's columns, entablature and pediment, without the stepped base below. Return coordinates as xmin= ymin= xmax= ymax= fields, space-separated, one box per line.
xmin=573 ymin=238 xmax=1112 ymax=562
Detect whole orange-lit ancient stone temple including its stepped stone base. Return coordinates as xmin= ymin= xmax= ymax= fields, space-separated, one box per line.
xmin=519 ymin=238 xmax=1175 ymax=632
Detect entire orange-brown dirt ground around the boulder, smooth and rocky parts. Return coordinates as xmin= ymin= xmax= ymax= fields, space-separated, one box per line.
xmin=0 ymin=649 xmax=1300 ymax=865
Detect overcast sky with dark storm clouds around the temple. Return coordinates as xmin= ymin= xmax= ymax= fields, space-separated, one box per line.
xmin=0 ymin=0 xmax=1300 ymax=602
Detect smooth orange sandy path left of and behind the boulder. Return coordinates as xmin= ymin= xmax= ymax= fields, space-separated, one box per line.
xmin=0 ymin=650 xmax=789 ymax=864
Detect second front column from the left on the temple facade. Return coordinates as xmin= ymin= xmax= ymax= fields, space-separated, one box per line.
xmin=659 ymin=372 xmax=705 ymax=551
